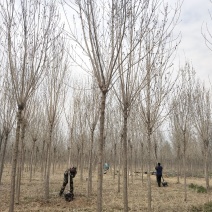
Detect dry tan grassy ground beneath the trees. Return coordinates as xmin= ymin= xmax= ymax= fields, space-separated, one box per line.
xmin=0 ymin=168 xmax=212 ymax=212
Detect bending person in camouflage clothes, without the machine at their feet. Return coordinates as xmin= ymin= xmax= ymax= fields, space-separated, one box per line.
xmin=59 ymin=167 xmax=77 ymax=198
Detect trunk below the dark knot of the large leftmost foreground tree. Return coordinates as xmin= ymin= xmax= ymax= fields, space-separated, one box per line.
xmin=9 ymin=106 xmax=23 ymax=212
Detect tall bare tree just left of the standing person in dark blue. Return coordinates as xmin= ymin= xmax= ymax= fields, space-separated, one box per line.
xmin=137 ymin=1 xmax=180 ymax=211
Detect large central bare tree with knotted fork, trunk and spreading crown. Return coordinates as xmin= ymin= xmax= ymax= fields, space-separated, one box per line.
xmin=62 ymin=0 xmax=127 ymax=211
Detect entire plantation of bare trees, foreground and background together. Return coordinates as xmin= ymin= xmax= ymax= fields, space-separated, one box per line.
xmin=0 ymin=0 xmax=211 ymax=212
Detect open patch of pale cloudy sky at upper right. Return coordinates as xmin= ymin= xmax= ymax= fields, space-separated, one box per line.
xmin=175 ymin=0 xmax=212 ymax=85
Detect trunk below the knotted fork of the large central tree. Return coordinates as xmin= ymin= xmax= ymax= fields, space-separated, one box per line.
xmin=97 ymin=91 xmax=107 ymax=212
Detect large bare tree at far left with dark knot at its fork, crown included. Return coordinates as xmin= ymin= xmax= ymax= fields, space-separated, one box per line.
xmin=0 ymin=0 xmax=63 ymax=212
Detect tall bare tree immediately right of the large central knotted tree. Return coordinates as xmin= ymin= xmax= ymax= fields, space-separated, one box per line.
xmin=113 ymin=1 xmax=154 ymax=211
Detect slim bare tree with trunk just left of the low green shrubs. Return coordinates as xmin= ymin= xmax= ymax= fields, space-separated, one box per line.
xmin=173 ymin=63 xmax=195 ymax=201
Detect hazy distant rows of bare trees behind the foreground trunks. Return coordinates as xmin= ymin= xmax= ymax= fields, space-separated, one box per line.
xmin=1 ymin=71 xmax=211 ymax=209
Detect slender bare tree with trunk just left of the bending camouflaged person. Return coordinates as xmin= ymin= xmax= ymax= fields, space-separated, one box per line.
xmin=41 ymin=37 xmax=68 ymax=200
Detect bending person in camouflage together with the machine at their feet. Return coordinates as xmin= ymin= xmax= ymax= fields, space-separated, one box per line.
xmin=59 ymin=167 xmax=77 ymax=202
